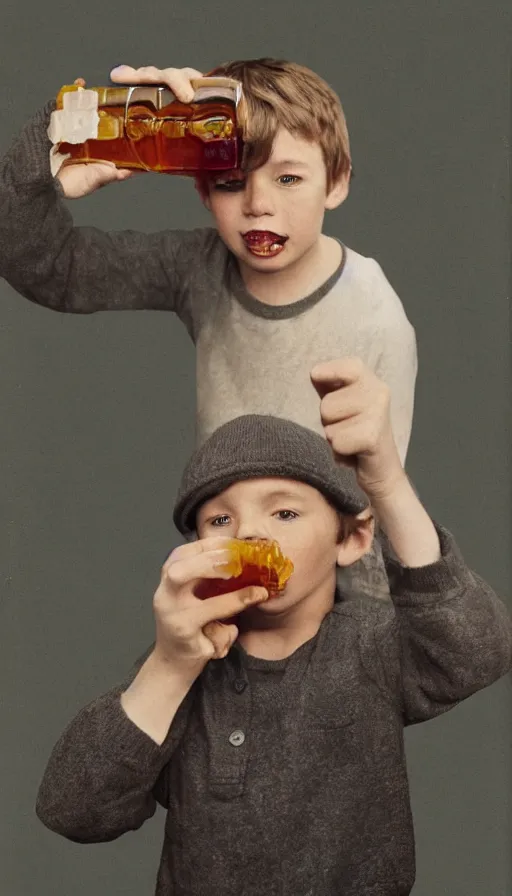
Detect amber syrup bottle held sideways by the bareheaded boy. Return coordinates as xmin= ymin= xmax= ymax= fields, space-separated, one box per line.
xmin=48 ymin=77 xmax=242 ymax=176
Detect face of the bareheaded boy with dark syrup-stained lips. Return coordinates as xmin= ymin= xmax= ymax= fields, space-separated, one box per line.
xmin=203 ymin=128 xmax=348 ymax=273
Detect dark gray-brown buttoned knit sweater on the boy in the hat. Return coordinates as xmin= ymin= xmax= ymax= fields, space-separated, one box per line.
xmin=37 ymin=529 xmax=512 ymax=896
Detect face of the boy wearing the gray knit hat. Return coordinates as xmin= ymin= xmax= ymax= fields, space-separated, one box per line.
xmin=197 ymin=478 xmax=369 ymax=616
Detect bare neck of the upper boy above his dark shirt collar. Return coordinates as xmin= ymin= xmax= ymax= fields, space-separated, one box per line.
xmin=239 ymin=234 xmax=343 ymax=306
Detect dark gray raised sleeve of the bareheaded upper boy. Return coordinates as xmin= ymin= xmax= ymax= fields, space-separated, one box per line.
xmin=0 ymin=102 xmax=214 ymax=315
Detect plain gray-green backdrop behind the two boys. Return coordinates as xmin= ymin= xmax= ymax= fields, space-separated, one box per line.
xmin=0 ymin=0 xmax=512 ymax=896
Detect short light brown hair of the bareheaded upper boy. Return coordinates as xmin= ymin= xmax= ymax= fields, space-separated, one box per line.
xmin=209 ymin=59 xmax=352 ymax=190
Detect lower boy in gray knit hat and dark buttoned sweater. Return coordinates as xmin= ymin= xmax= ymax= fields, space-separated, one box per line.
xmin=37 ymin=362 xmax=512 ymax=896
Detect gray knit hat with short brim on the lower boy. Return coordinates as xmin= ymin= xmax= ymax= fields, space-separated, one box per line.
xmin=173 ymin=414 xmax=369 ymax=535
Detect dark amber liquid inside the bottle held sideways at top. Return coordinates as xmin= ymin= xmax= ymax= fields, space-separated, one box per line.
xmin=59 ymin=88 xmax=242 ymax=176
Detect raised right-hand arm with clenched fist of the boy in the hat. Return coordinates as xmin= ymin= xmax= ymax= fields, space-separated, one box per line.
xmin=312 ymin=359 xmax=512 ymax=723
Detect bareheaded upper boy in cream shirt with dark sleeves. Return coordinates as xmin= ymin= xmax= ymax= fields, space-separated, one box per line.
xmin=0 ymin=59 xmax=417 ymax=596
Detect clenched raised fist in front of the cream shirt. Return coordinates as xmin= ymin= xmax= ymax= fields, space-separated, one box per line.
xmin=311 ymin=358 xmax=405 ymax=499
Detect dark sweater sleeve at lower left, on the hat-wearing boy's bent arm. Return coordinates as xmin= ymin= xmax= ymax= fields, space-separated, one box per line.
xmin=36 ymin=662 xmax=193 ymax=843
